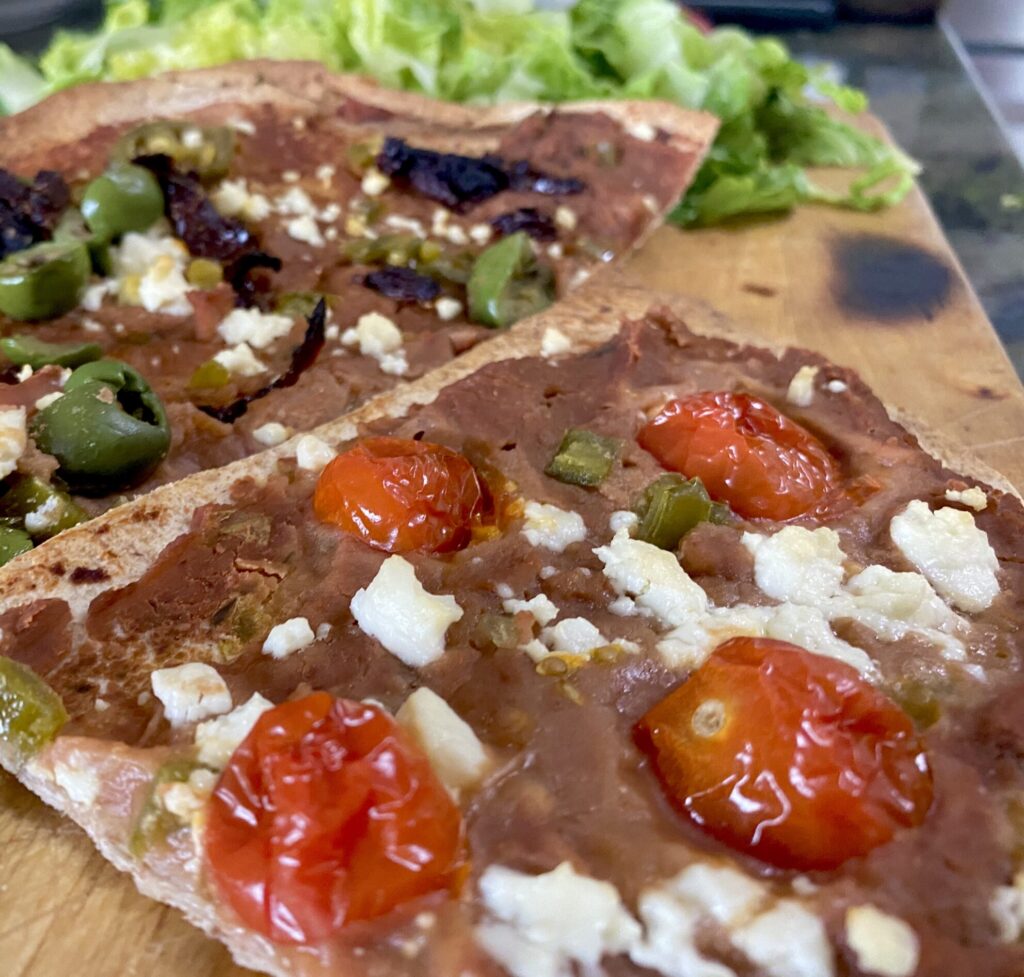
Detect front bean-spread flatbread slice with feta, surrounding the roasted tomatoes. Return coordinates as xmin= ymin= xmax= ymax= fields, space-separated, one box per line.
xmin=0 ymin=284 xmax=1024 ymax=977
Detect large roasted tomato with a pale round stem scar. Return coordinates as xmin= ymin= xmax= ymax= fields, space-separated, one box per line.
xmin=637 ymin=638 xmax=932 ymax=870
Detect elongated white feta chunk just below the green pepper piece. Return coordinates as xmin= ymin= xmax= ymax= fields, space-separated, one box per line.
xmin=594 ymin=529 xmax=708 ymax=628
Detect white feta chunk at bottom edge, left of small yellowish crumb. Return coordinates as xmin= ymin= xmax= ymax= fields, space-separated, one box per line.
xmin=732 ymin=899 xmax=836 ymax=977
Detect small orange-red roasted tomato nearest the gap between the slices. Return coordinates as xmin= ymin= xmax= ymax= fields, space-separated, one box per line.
xmin=313 ymin=437 xmax=484 ymax=553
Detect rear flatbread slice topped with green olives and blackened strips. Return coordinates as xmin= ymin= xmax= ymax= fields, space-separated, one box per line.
xmin=0 ymin=61 xmax=717 ymax=540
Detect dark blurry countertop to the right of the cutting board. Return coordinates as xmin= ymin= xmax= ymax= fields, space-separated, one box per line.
xmin=779 ymin=24 xmax=1024 ymax=377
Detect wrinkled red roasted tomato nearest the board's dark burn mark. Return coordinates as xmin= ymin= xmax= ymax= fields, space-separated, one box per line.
xmin=637 ymin=392 xmax=839 ymax=519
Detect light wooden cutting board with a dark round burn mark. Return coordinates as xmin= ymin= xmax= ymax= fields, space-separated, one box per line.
xmin=0 ymin=171 xmax=1024 ymax=977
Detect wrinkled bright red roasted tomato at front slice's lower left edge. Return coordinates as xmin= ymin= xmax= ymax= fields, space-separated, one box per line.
xmin=204 ymin=692 xmax=465 ymax=944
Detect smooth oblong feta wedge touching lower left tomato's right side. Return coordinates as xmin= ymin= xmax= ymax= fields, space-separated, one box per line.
xmin=394 ymin=686 xmax=490 ymax=796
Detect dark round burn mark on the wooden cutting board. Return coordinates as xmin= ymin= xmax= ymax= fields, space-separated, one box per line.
xmin=833 ymin=235 xmax=955 ymax=322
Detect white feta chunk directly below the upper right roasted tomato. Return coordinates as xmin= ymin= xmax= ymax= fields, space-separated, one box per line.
xmin=742 ymin=525 xmax=846 ymax=604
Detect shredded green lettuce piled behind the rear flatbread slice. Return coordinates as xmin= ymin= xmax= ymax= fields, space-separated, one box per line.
xmin=0 ymin=0 xmax=918 ymax=226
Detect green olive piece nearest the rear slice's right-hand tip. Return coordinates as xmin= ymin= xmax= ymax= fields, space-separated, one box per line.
xmin=466 ymin=230 xmax=554 ymax=329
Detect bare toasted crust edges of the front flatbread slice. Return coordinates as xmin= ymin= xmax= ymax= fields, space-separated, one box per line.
xmin=0 ymin=281 xmax=1012 ymax=977
